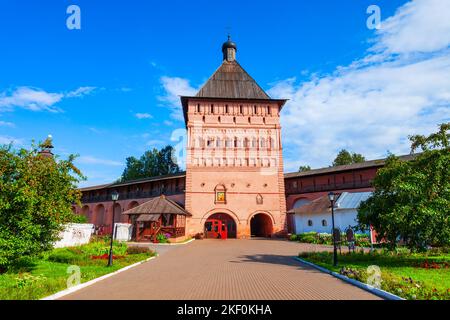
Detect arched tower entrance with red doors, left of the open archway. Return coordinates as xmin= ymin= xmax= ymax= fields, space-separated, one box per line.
xmin=205 ymin=213 xmax=237 ymax=239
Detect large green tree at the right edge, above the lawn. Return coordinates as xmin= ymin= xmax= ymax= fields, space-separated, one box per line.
xmin=358 ymin=123 xmax=450 ymax=250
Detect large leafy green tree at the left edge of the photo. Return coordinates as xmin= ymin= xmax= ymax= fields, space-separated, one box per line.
xmin=0 ymin=140 xmax=84 ymax=271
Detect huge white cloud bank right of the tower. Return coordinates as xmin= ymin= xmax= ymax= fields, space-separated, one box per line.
xmin=269 ymin=0 xmax=450 ymax=171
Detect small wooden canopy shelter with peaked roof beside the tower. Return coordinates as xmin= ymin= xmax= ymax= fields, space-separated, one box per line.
xmin=123 ymin=195 xmax=191 ymax=241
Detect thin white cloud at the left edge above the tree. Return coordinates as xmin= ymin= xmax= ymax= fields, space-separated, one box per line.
xmin=0 ymin=87 xmax=95 ymax=112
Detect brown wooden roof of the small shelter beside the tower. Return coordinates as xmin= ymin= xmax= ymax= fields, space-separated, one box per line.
xmin=123 ymin=195 xmax=191 ymax=216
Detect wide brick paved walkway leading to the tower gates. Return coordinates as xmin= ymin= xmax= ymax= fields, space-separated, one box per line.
xmin=64 ymin=239 xmax=378 ymax=300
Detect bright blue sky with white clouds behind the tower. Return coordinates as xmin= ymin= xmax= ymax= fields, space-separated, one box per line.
xmin=0 ymin=0 xmax=450 ymax=185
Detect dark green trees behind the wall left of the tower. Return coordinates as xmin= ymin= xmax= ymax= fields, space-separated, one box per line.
xmin=120 ymin=145 xmax=180 ymax=182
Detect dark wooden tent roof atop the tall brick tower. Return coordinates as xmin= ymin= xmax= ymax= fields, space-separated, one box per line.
xmin=196 ymin=60 xmax=270 ymax=100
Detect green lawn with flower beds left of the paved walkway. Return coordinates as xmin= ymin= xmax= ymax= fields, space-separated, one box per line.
xmin=0 ymin=240 xmax=155 ymax=300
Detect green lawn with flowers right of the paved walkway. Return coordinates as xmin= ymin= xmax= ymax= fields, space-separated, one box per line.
xmin=299 ymin=251 xmax=450 ymax=300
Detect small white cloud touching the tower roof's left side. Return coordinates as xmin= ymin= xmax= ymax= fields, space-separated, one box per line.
xmin=159 ymin=77 xmax=198 ymax=120
